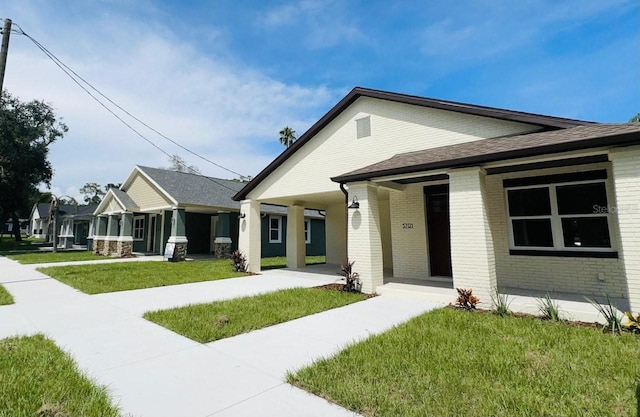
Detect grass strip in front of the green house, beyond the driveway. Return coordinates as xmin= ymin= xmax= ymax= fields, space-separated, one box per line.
xmin=38 ymin=259 xmax=246 ymax=294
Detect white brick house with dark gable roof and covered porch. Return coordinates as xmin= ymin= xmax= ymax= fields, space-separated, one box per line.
xmin=234 ymin=88 xmax=640 ymax=311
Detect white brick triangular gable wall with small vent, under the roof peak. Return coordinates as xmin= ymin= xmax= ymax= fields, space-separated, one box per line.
xmin=248 ymin=98 xmax=534 ymax=202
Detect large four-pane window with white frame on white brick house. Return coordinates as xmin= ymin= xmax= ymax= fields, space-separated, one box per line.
xmin=506 ymin=176 xmax=612 ymax=251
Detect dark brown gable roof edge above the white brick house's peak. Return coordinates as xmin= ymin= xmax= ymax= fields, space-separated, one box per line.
xmin=233 ymin=87 xmax=593 ymax=201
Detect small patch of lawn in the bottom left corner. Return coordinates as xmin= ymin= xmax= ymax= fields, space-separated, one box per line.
xmin=0 ymin=335 xmax=119 ymax=417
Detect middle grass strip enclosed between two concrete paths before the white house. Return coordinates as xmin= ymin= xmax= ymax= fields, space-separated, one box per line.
xmin=144 ymin=288 xmax=366 ymax=343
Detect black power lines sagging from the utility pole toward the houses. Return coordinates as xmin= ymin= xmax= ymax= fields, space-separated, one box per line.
xmin=12 ymin=23 xmax=250 ymax=193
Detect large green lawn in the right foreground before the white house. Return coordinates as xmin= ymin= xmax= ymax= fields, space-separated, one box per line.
xmin=287 ymin=308 xmax=640 ymax=417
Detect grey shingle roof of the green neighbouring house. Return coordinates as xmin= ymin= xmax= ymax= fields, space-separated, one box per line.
xmin=138 ymin=166 xmax=245 ymax=209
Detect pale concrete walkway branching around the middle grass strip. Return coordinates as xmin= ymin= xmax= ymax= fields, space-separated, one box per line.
xmin=0 ymin=257 xmax=435 ymax=417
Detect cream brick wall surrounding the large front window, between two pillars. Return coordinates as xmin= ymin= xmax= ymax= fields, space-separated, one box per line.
xmin=486 ymin=163 xmax=626 ymax=297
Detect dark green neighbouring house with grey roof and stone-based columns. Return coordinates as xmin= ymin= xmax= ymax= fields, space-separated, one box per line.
xmin=89 ymin=166 xmax=325 ymax=259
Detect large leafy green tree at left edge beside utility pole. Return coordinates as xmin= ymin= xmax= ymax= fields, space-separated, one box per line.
xmin=0 ymin=91 xmax=68 ymax=240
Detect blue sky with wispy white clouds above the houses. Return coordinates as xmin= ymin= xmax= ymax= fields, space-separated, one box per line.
xmin=0 ymin=0 xmax=640 ymax=200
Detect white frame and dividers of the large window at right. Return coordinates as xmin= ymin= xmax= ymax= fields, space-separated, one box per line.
xmin=504 ymin=179 xmax=616 ymax=252
